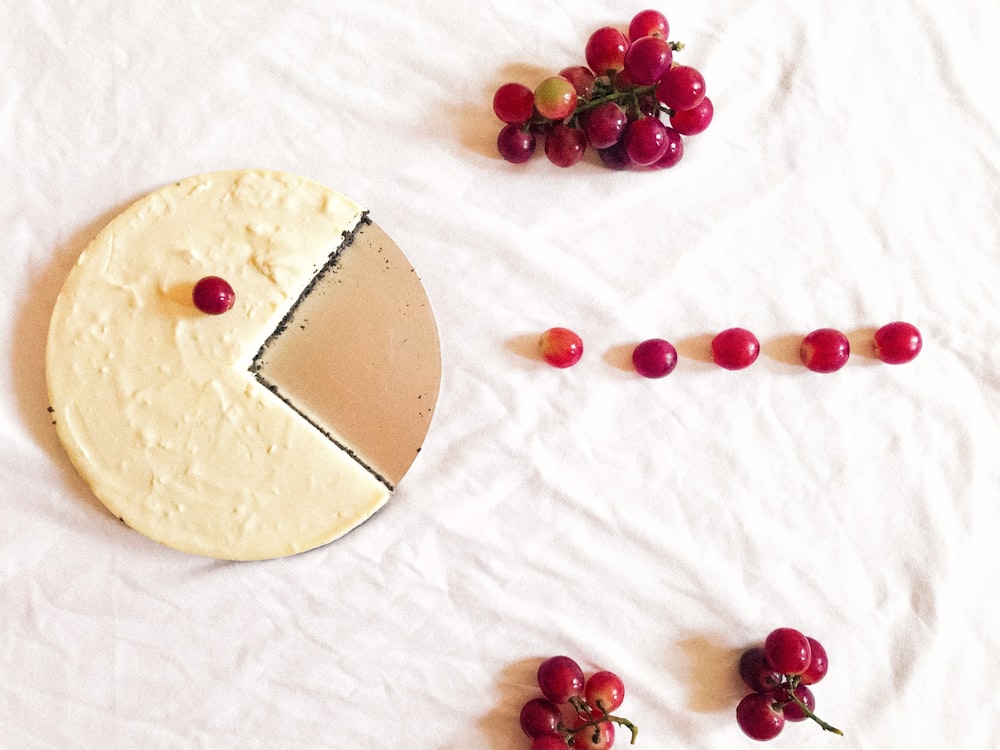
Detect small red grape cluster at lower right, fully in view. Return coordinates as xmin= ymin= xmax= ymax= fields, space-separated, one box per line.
xmin=736 ymin=628 xmax=843 ymax=740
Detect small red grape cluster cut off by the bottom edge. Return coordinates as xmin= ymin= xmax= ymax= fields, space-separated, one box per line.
xmin=520 ymin=656 xmax=639 ymax=750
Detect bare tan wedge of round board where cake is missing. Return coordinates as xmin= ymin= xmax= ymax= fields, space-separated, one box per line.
xmin=250 ymin=213 xmax=441 ymax=491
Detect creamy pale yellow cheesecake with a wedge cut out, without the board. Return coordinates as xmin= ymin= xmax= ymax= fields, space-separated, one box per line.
xmin=46 ymin=170 xmax=389 ymax=560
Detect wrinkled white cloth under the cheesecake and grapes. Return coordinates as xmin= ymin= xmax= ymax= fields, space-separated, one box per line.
xmin=0 ymin=0 xmax=1000 ymax=750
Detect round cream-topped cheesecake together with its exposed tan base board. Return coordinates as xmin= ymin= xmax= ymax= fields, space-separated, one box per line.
xmin=46 ymin=170 xmax=440 ymax=560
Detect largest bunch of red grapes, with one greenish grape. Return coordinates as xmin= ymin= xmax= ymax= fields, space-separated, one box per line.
xmin=493 ymin=10 xmax=714 ymax=169
